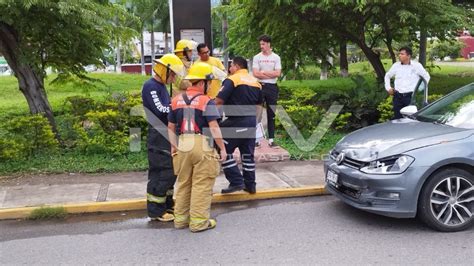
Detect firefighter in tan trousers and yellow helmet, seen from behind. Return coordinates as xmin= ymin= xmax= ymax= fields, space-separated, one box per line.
xmin=168 ymin=63 xmax=227 ymax=232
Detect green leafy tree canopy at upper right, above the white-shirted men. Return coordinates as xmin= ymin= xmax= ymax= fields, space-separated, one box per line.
xmin=229 ymin=0 xmax=468 ymax=81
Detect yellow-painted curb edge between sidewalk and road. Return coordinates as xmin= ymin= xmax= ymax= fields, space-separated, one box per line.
xmin=0 ymin=185 xmax=328 ymax=220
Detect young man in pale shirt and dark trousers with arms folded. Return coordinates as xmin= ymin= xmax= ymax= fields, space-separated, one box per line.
xmin=252 ymin=35 xmax=281 ymax=147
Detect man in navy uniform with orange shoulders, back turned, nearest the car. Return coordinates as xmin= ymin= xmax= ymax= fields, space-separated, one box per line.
xmin=216 ymin=57 xmax=263 ymax=194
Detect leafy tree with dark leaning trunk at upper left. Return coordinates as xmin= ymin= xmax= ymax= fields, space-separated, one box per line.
xmin=0 ymin=0 xmax=134 ymax=137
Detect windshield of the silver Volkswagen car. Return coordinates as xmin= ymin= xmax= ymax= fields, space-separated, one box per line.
xmin=416 ymin=83 xmax=474 ymax=129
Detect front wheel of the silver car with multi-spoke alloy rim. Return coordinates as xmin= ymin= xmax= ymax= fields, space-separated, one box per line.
xmin=418 ymin=168 xmax=474 ymax=232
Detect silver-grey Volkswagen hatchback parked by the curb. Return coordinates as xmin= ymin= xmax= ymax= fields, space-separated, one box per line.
xmin=324 ymin=83 xmax=474 ymax=232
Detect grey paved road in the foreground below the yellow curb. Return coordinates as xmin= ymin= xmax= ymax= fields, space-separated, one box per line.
xmin=0 ymin=196 xmax=474 ymax=265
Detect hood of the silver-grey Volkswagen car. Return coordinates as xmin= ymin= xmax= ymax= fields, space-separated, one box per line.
xmin=335 ymin=118 xmax=474 ymax=162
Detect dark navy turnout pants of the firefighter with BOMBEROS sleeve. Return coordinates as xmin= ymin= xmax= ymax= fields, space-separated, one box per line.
xmin=146 ymin=126 xmax=176 ymax=218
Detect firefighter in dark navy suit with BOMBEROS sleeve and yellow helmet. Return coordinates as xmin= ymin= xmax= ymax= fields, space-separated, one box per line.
xmin=142 ymin=54 xmax=184 ymax=222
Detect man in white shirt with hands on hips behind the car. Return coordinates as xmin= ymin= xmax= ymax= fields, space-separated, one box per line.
xmin=385 ymin=47 xmax=430 ymax=119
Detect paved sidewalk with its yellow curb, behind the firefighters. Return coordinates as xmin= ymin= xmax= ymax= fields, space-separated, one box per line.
xmin=0 ymin=141 xmax=325 ymax=219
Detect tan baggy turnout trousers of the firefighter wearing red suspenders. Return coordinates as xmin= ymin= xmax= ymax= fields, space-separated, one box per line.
xmin=173 ymin=134 xmax=220 ymax=231
